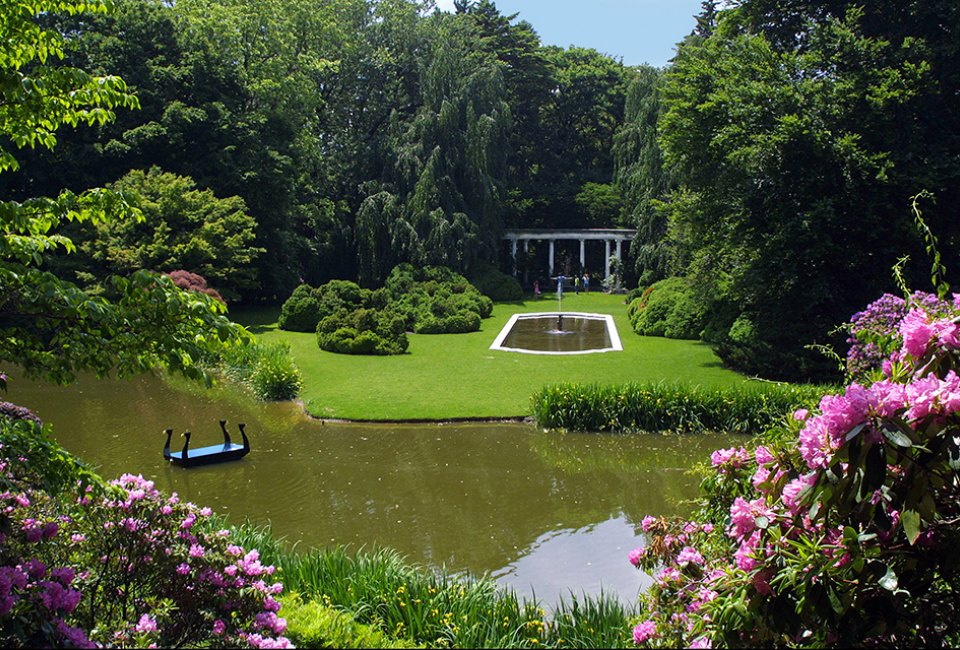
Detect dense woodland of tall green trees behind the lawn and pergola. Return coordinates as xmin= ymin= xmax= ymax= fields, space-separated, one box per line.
xmin=0 ymin=0 xmax=960 ymax=378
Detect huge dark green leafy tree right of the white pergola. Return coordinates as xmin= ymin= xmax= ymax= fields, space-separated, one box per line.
xmin=660 ymin=0 xmax=960 ymax=377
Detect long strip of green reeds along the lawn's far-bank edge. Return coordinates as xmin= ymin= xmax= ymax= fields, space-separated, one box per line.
xmin=531 ymin=382 xmax=826 ymax=433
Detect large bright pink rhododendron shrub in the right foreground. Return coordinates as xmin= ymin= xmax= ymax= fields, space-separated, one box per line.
xmin=629 ymin=294 xmax=960 ymax=647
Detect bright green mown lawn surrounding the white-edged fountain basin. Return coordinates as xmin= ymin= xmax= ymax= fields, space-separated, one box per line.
xmin=232 ymin=293 xmax=747 ymax=420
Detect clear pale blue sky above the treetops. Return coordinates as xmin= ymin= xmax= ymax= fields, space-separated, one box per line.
xmin=436 ymin=0 xmax=701 ymax=67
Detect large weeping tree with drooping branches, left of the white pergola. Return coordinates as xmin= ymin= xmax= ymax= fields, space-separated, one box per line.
xmin=356 ymin=15 xmax=511 ymax=286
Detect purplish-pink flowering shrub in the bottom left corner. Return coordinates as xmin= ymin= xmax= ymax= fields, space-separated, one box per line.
xmin=0 ymin=410 xmax=290 ymax=648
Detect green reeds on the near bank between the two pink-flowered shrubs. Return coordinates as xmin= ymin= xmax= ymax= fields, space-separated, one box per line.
xmin=234 ymin=527 xmax=637 ymax=648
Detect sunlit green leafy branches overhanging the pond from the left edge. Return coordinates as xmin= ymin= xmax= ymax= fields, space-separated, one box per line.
xmin=0 ymin=0 xmax=243 ymax=381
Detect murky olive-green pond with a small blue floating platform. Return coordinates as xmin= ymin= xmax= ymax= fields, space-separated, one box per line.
xmin=6 ymin=376 xmax=734 ymax=605
